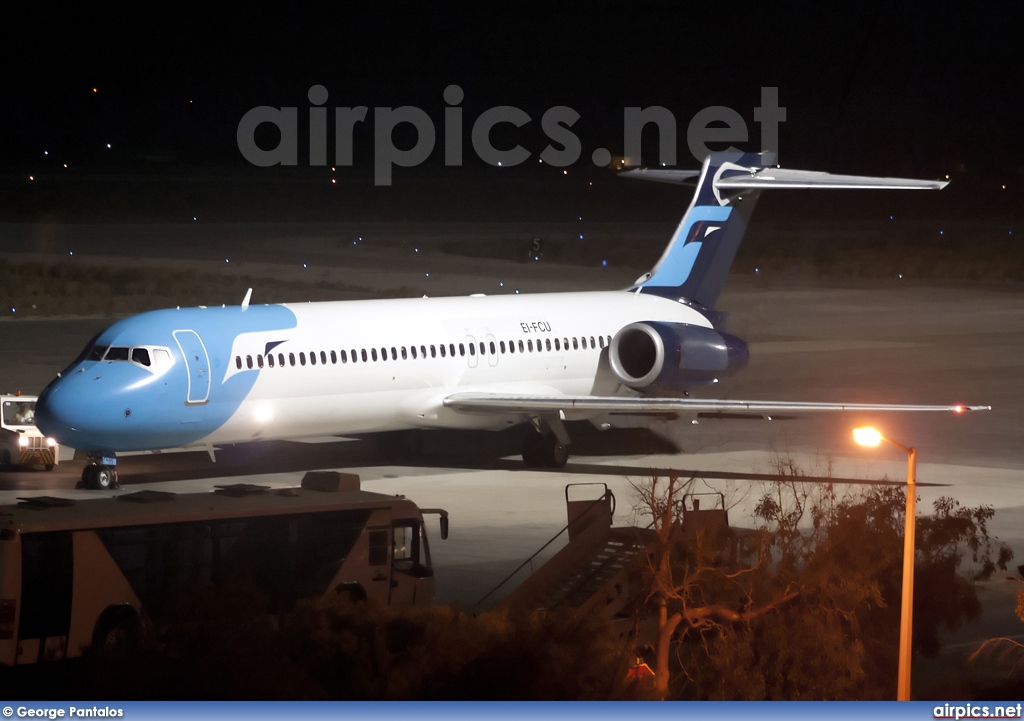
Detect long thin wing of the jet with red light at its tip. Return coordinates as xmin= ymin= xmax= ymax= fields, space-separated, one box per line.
xmin=443 ymin=392 xmax=992 ymax=416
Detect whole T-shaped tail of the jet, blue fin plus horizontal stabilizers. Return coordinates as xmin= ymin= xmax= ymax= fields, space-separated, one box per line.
xmin=624 ymin=153 xmax=947 ymax=310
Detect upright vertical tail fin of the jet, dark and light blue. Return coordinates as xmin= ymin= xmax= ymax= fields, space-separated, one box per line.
xmin=634 ymin=153 xmax=774 ymax=309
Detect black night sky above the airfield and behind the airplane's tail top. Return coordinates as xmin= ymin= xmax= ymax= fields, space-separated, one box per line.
xmin=0 ymin=0 xmax=1024 ymax=219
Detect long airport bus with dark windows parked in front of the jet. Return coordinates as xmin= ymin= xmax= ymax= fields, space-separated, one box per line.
xmin=0 ymin=473 xmax=447 ymax=666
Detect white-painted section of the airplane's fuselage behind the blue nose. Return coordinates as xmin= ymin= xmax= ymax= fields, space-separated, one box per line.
xmin=214 ymin=291 xmax=711 ymax=442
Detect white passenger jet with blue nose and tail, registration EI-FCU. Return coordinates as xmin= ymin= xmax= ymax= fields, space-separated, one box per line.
xmin=36 ymin=152 xmax=988 ymax=489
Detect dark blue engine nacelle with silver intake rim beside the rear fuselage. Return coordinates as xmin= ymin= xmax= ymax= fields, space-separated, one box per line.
xmin=608 ymin=321 xmax=750 ymax=389
